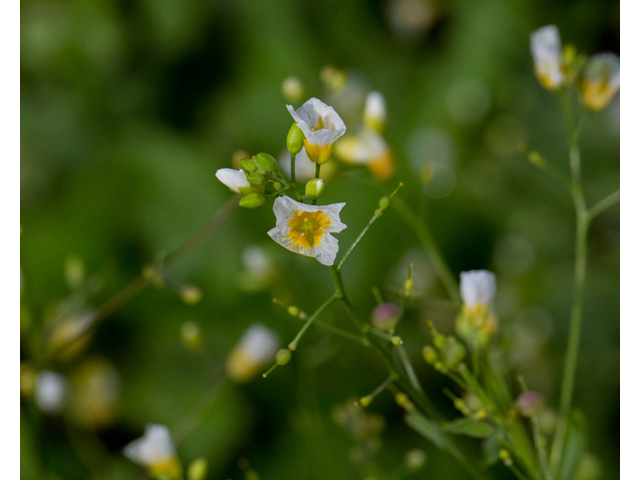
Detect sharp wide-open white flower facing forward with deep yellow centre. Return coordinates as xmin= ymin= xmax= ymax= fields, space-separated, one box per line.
xmin=268 ymin=197 xmax=347 ymax=266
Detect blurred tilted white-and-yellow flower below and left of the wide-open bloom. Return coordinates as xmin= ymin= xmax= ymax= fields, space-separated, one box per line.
xmin=225 ymin=323 xmax=280 ymax=383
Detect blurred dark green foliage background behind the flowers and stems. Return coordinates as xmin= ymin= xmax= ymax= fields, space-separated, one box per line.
xmin=20 ymin=0 xmax=620 ymax=479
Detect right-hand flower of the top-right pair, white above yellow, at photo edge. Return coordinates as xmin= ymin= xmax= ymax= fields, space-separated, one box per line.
xmin=580 ymin=53 xmax=620 ymax=111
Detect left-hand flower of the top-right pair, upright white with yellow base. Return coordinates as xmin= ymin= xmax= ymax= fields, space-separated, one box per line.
xmin=531 ymin=25 xmax=565 ymax=90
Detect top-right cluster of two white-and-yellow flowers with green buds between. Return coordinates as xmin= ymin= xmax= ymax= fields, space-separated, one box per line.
xmin=531 ymin=25 xmax=620 ymax=111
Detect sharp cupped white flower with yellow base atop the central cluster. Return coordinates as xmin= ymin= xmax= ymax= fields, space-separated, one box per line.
xmin=287 ymin=98 xmax=347 ymax=164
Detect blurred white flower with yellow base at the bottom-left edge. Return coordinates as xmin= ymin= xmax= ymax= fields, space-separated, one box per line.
xmin=124 ymin=423 xmax=182 ymax=480
